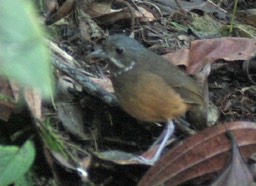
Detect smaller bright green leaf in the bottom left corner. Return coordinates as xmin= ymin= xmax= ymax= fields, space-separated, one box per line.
xmin=0 ymin=141 xmax=35 ymax=186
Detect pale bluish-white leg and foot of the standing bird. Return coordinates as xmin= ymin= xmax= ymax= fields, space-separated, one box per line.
xmin=132 ymin=120 xmax=175 ymax=165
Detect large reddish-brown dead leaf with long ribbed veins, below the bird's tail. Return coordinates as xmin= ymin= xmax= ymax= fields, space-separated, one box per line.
xmin=139 ymin=122 xmax=256 ymax=186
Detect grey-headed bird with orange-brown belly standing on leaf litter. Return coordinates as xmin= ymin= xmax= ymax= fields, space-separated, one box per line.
xmin=87 ymin=34 xmax=207 ymax=164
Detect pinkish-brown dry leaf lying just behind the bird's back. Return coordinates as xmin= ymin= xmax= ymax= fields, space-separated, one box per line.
xmin=164 ymin=37 xmax=256 ymax=74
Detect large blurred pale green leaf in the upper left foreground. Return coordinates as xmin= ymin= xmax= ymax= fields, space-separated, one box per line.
xmin=0 ymin=0 xmax=53 ymax=97
